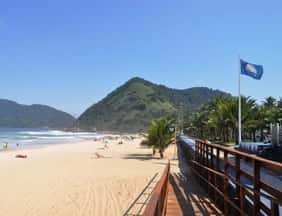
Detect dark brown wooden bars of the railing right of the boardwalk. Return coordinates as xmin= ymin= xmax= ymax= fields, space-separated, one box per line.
xmin=193 ymin=140 xmax=282 ymax=215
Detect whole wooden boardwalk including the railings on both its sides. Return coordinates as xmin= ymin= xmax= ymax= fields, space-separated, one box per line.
xmin=143 ymin=140 xmax=282 ymax=216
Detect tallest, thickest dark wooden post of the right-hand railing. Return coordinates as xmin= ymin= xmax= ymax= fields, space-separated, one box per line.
xmin=253 ymin=160 xmax=260 ymax=216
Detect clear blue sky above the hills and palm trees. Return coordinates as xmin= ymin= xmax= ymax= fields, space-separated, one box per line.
xmin=0 ymin=0 xmax=282 ymax=113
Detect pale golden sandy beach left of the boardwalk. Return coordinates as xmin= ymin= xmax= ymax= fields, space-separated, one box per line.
xmin=0 ymin=138 xmax=171 ymax=216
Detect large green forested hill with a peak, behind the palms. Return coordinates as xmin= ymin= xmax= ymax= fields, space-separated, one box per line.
xmin=76 ymin=78 xmax=229 ymax=132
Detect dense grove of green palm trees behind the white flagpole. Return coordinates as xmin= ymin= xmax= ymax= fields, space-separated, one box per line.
xmin=186 ymin=96 xmax=282 ymax=143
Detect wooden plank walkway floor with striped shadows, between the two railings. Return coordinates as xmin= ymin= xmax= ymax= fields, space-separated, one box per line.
xmin=167 ymin=144 xmax=224 ymax=216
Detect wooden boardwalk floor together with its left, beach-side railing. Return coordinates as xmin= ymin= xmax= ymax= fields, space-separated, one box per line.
xmin=142 ymin=143 xmax=224 ymax=216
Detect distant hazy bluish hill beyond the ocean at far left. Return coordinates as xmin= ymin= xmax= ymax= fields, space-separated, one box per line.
xmin=0 ymin=99 xmax=75 ymax=128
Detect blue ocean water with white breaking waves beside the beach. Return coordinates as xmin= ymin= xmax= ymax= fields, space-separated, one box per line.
xmin=0 ymin=128 xmax=101 ymax=150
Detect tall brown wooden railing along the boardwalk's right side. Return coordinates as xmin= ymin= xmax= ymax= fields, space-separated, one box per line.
xmin=192 ymin=140 xmax=282 ymax=216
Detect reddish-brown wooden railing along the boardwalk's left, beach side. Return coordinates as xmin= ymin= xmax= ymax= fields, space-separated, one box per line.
xmin=143 ymin=162 xmax=170 ymax=216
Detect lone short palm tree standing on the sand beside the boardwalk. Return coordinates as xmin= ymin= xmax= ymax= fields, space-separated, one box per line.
xmin=145 ymin=118 xmax=175 ymax=158
